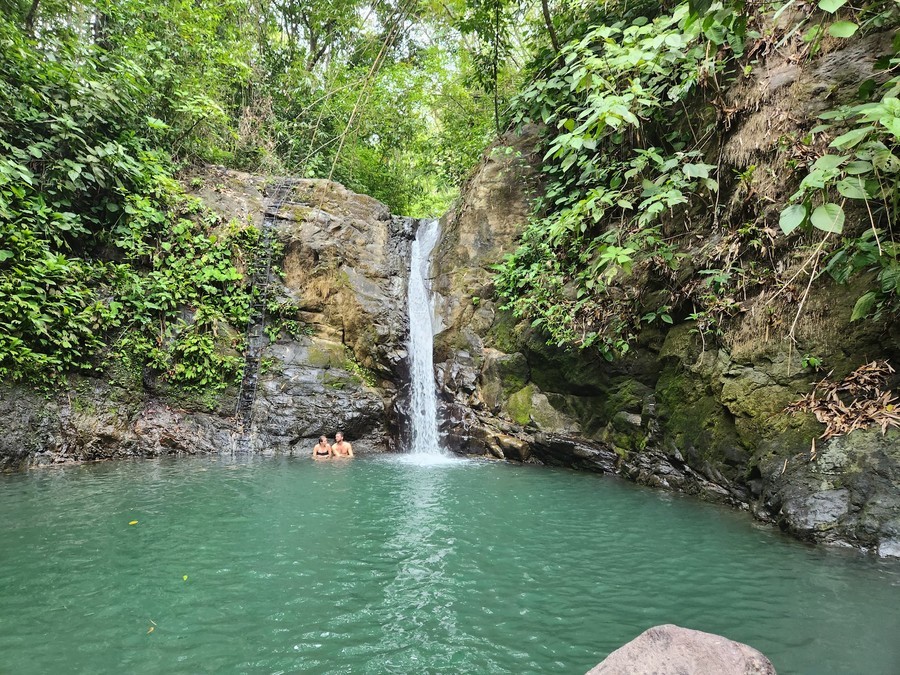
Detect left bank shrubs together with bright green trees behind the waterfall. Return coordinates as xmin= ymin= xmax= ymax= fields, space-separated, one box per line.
xmin=0 ymin=0 xmax=506 ymax=391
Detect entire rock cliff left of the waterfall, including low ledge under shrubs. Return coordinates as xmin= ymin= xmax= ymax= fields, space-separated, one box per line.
xmin=0 ymin=168 xmax=417 ymax=469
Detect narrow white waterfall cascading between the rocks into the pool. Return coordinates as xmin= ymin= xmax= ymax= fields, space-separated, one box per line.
xmin=407 ymin=220 xmax=444 ymax=456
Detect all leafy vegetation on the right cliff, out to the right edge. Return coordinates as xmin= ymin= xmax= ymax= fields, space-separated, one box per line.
xmin=497 ymin=0 xmax=900 ymax=358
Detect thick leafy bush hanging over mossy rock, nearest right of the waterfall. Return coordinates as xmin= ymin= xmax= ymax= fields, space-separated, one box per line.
xmin=498 ymin=3 xmax=756 ymax=358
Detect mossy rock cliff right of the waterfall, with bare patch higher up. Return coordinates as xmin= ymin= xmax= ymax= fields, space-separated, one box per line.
xmin=434 ymin=36 xmax=900 ymax=555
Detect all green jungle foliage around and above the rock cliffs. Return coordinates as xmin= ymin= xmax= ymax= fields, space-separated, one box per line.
xmin=0 ymin=0 xmax=900 ymax=391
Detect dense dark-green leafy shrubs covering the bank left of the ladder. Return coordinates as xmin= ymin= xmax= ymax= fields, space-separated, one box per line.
xmin=0 ymin=19 xmax=249 ymax=389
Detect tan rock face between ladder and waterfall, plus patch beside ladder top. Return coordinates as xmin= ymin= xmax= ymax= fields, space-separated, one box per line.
xmin=200 ymin=172 xmax=417 ymax=452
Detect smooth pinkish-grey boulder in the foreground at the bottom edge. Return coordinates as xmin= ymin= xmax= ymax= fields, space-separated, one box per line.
xmin=587 ymin=624 xmax=775 ymax=675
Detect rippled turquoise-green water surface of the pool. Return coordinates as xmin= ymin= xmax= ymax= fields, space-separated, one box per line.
xmin=0 ymin=458 xmax=900 ymax=674
